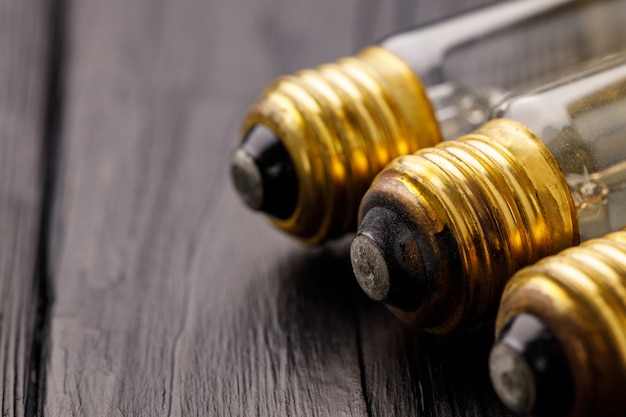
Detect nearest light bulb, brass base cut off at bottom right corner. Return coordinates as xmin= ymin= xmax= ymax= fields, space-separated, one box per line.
xmin=489 ymin=228 xmax=626 ymax=417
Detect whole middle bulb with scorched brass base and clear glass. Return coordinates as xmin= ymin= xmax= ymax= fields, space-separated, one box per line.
xmin=351 ymin=55 xmax=626 ymax=333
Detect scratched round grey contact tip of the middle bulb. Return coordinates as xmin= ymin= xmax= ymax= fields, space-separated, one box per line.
xmin=350 ymin=235 xmax=389 ymax=301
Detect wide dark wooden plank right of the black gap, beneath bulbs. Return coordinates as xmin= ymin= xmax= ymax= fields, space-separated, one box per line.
xmin=44 ymin=0 xmax=510 ymax=416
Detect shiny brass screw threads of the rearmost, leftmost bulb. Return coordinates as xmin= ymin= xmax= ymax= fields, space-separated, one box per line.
xmin=243 ymin=46 xmax=440 ymax=243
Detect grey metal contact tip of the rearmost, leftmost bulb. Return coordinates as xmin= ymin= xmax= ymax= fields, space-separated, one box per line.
xmin=230 ymin=148 xmax=263 ymax=210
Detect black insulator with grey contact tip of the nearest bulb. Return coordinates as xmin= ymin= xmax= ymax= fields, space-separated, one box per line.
xmin=489 ymin=313 xmax=574 ymax=417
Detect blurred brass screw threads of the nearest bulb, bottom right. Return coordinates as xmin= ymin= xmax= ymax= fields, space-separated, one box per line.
xmin=496 ymin=229 xmax=626 ymax=416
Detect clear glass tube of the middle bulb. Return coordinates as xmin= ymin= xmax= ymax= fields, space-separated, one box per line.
xmin=494 ymin=56 xmax=626 ymax=240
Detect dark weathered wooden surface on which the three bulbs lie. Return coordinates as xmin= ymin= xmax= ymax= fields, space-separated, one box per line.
xmin=0 ymin=0 xmax=508 ymax=416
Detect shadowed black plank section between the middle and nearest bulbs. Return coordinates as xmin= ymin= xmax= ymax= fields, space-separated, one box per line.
xmin=359 ymin=309 xmax=514 ymax=416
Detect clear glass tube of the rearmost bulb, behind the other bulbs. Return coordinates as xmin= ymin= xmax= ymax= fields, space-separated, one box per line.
xmin=380 ymin=0 xmax=626 ymax=139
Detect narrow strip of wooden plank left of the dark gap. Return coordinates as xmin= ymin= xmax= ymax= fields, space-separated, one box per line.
xmin=0 ymin=0 xmax=56 ymax=416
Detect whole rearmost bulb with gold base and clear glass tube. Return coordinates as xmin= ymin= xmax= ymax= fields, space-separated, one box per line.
xmin=231 ymin=0 xmax=626 ymax=243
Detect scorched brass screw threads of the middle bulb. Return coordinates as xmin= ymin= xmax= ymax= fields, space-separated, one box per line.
xmin=359 ymin=119 xmax=579 ymax=333
